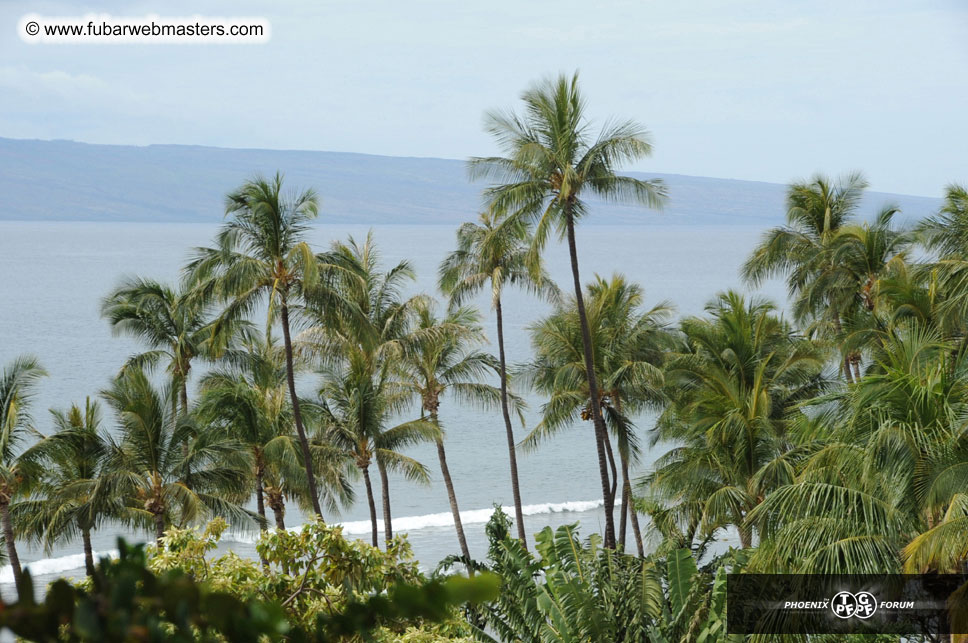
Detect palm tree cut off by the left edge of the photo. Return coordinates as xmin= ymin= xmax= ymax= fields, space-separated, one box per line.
xmin=0 ymin=355 xmax=47 ymax=589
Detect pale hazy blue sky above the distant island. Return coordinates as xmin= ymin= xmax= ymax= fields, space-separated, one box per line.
xmin=0 ymin=0 xmax=968 ymax=196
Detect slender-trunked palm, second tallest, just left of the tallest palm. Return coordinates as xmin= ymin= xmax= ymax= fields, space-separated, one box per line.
xmin=440 ymin=211 xmax=559 ymax=550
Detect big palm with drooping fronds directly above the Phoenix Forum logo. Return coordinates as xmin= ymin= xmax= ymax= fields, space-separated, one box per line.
xmin=748 ymin=320 xmax=968 ymax=573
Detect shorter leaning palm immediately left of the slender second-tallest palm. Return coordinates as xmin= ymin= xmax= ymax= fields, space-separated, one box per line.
xmin=399 ymin=302 xmax=501 ymax=573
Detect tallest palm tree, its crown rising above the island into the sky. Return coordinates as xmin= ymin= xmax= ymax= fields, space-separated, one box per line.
xmin=471 ymin=74 xmax=665 ymax=548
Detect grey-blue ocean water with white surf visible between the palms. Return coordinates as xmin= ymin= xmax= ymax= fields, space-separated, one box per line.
xmin=0 ymin=222 xmax=784 ymax=593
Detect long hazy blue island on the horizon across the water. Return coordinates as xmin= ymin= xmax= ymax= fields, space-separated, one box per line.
xmin=0 ymin=138 xmax=941 ymax=226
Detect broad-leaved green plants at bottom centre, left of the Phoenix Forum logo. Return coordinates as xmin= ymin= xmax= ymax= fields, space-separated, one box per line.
xmin=470 ymin=508 xmax=742 ymax=643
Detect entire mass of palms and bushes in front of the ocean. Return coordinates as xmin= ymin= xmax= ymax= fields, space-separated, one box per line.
xmin=0 ymin=75 xmax=968 ymax=643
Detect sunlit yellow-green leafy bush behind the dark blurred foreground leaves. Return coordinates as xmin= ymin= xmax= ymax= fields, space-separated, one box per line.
xmin=148 ymin=520 xmax=495 ymax=640
